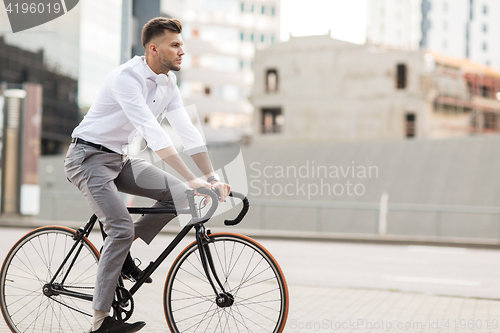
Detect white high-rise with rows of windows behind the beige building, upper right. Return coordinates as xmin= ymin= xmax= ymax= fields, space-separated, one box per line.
xmin=367 ymin=0 xmax=500 ymax=70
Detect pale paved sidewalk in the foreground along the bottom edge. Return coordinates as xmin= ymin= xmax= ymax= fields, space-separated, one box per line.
xmin=0 ymin=281 xmax=500 ymax=333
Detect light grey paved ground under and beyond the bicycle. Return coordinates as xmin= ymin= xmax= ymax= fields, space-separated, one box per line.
xmin=0 ymin=224 xmax=500 ymax=333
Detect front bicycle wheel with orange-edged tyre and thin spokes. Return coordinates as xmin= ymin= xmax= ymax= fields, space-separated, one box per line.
xmin=164 ymin=233 xmax=288 ymax=333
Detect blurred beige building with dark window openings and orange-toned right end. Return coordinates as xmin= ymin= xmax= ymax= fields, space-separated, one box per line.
xmin=251 ymin=35 xmax=500 ymax=145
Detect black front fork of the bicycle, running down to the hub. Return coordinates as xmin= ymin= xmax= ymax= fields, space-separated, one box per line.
xmin=195 ymin=225 xmax=234 ymax=308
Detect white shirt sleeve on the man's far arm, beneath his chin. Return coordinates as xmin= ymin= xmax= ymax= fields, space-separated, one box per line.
xmin=165 ymin=85 xmax=207 ymax=155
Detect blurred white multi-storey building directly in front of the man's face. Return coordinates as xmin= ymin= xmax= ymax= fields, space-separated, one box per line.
xmin=161 ymin=0 xmax=280 ymax=135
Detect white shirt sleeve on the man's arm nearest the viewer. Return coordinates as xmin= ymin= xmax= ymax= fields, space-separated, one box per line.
xmin=111 ymin=70 xmax=173 ymax=151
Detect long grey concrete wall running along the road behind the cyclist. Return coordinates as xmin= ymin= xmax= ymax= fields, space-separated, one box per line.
xmin=38 ymin=136 xmax=500 ymax=241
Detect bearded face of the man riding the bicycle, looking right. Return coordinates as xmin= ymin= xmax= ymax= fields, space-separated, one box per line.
xmin=157 ymin=30 xmax=184 ymax=73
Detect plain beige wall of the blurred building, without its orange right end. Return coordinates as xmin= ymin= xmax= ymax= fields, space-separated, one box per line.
xmin=251 ymin=36 xmax=432 ymax=145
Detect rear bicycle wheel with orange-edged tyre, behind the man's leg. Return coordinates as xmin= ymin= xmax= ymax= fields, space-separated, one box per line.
xmin=0 ymin=226 xmax=99 ymax=332
